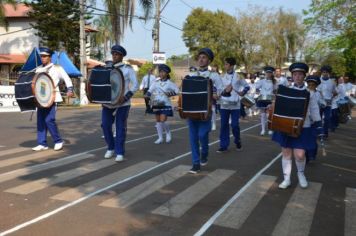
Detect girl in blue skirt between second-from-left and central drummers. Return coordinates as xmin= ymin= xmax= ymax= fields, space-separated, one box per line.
xmin=146 ymin=64 xmax=179 ymax=144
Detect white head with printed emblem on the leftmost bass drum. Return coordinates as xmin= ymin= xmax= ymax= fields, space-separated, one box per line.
xmin=32 ymin=73 xmax=56 ymax=108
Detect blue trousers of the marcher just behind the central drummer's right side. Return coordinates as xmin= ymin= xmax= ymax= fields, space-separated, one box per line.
xmin=220 ymin=109 xmax=241 ymax=149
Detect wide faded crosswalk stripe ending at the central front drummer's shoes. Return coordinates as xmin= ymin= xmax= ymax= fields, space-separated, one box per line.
xmin=99 ymin=165 xmax=189 ymax=208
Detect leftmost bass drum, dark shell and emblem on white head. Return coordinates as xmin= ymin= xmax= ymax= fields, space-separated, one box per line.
xmin=15 ymin=72 xmax=56 ymax=112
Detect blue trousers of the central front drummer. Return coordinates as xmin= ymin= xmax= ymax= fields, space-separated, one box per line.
xmin=188 ymin=119 xmax=211 ymax=165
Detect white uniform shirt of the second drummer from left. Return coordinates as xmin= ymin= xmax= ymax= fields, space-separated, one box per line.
xmin=103 ymin=62 xmax=138 ymax=109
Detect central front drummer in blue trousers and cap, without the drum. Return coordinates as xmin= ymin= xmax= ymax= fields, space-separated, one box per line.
xmin=188 ymin=48 xmax=222 ymax=174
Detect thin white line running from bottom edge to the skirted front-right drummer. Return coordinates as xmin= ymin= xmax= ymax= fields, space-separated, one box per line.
xmin=194 ymin=153 xmax=282 ymax=236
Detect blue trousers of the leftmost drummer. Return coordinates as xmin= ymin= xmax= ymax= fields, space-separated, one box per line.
xmin=37 ymin=104 xmax=62 ymax=147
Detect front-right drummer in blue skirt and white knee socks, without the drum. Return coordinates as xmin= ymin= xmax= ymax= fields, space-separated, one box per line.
xmin=272 ymin=63 xmax=322 ymax=189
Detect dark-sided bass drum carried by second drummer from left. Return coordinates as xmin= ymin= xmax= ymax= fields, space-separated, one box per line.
xmin=87 ymin=66 xmax=125 ymax=106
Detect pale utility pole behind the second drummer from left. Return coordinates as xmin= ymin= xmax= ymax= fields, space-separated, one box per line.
xmin=79 ymin=0 xmax=89 ymax=105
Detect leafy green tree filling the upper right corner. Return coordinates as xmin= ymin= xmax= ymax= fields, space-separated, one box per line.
xmin=304 ymin=0 xmax=356 ymax=77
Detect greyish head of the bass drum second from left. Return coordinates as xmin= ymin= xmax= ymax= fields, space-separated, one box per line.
xmin=110 ymin=69 xmax=125 ymax=105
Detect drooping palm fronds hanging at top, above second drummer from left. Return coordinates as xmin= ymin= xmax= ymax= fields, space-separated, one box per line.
xmin=105 ymin=0 xmax=156 ymax=44
